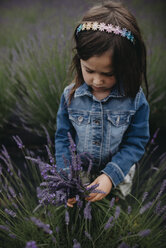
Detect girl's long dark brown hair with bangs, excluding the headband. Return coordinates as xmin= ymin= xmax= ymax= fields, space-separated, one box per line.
xmin=69 ymin=1 xmax=148 ymax=103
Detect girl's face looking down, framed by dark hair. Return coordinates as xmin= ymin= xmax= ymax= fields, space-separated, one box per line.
xmin=80 ymin=51 xmax=116 ymax=100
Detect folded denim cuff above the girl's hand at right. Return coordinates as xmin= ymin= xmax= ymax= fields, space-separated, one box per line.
xmin=101 ymin=162 xmax=125 ymax=187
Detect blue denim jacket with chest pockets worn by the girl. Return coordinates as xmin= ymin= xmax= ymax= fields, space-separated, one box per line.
xmin=55 ymin=83 xmax=149 ymax=187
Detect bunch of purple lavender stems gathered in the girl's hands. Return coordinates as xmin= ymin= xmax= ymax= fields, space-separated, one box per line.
xmin=27 ymin=134 xmax=101 ymax=205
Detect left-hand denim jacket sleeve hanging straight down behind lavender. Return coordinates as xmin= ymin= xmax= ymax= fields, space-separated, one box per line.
xmin=55 ymin=94 xmax=74 ymax=169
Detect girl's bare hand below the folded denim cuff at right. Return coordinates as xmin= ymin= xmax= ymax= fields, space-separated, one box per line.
xmin=86 ymin=173 xmax=112 ymax=202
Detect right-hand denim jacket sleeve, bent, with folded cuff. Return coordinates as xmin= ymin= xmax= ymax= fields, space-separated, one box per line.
xmin=102 ymin=92 xmax=150 ymax=187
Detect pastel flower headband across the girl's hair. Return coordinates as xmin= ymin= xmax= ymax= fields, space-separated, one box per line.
xmin=76 ymin=22 xmax=135 ymax=43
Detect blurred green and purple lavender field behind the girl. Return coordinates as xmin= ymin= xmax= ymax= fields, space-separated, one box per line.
xmin=0 ymin=0 xmax=166 ymax=156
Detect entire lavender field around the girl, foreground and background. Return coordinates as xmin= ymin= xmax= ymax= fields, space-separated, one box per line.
xmin=0 ymin=0 xmax=166 ymax=248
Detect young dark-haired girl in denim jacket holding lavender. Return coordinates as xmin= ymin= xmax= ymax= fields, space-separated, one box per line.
xmin=55 ymin=1 xmax=149 ymax=207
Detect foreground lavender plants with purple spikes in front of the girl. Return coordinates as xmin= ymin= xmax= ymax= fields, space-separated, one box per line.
xmin=0 ymin=131 xmax=166 ymax=248
